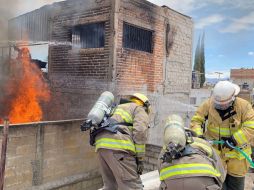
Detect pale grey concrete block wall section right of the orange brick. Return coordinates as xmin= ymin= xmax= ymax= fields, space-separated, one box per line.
xmin=163 ymin=7 xmax=193 ymax=96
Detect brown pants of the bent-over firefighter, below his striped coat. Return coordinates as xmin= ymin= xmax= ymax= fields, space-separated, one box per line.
xmin=160 ymin=177 xmax=221 ymax=190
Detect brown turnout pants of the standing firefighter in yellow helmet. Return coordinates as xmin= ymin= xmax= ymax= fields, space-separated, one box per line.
xmin=97 ymin=149 xmax=143 ymax=190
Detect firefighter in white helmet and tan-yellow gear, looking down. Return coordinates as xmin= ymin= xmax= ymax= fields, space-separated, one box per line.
xmin=190 ymin=81 xmax=254 ymax=190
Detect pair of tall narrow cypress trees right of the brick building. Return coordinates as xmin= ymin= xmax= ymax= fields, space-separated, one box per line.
xmin=194 ymin=32 xmax=205 ymax=87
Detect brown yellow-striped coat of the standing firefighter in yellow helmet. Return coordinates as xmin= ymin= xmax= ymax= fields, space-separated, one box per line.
xmin=95 ymin=103 xmax=149 ymax=157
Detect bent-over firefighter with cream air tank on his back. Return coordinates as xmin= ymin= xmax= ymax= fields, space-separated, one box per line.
xmin=158 ymin=115 xmax=226 ymax=190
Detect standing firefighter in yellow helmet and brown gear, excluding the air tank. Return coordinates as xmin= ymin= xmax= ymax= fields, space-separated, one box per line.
xmin=95 ymin=93 xmax=151 ymax=190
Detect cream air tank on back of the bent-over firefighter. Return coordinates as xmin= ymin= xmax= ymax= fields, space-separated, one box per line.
xmin=163 ymin=114 xmax=186 ymax=149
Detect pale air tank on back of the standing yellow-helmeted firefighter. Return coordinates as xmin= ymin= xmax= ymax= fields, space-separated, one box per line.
xmin=87 ymin=91 xmax=114 ymax=124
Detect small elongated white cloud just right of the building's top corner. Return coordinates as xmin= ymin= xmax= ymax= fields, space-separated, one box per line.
xmin=195 ymin=14 xmax=225 ymax=29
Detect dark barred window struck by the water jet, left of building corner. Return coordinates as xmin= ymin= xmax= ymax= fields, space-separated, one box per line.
xmin=72 ymin=22 xmax=105 ymax=48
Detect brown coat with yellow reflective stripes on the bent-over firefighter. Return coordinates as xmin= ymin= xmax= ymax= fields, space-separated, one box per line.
xmin=158 ymin=137 xmax=226 ymax=189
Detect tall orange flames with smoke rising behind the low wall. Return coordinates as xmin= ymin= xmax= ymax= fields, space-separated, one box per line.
xmin=0 ymin=46 xmax=50 ymax=123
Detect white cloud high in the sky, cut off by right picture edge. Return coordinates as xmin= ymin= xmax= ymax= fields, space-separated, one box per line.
xmin=220 ymin=11 xmax=254 ymax=33
